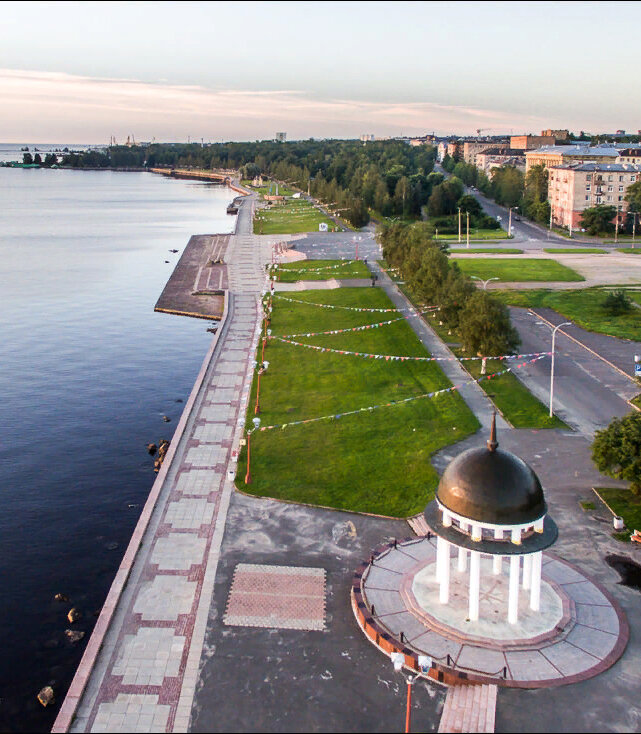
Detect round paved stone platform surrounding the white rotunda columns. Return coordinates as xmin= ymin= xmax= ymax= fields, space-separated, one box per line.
xmin=352 ymin=537 xmax=629 ymax=688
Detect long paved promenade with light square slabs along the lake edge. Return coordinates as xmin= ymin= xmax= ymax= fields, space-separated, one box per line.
xmin=53 ymin=197 xmax=282 ymax=732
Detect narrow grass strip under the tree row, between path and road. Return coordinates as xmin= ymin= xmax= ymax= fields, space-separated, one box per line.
xmin=426 ymin=316 xmax=568 ymax=428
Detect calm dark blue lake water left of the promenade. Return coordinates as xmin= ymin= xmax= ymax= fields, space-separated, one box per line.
xmin=0 ymin=168 xmax=234 ymax=731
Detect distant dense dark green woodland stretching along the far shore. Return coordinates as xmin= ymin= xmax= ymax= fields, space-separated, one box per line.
xmin=57 ymin=140 xmax=440 ymax=227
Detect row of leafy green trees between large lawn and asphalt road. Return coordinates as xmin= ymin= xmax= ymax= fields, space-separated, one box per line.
xmin=379 ymin=222 xmax=520 ymax=357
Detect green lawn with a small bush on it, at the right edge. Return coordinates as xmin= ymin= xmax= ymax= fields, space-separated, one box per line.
xmin=492 ymin=288 xmax=641 ymax=341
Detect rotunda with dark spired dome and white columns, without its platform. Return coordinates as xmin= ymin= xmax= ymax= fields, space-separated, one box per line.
xmin=424 ymin=416 xmax=558 ymax=624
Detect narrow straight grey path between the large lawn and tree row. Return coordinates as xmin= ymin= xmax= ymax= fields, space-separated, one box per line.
xmin=368 ymin=262 xmax=508 ymax=428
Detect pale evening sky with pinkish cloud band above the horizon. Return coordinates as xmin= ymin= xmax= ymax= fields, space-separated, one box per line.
xmin=0 ymin=1 xmax=641 ymax=143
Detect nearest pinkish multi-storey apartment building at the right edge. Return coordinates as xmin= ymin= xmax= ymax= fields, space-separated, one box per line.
xmin=548 ymin=163 xmax=641 ymax=229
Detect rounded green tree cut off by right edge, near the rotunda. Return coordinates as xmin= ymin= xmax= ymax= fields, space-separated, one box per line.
xmin=592 ymin=413 xmax=641 ymax=495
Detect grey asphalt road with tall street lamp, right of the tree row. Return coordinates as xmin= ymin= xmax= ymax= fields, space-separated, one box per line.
xmin=510 ymin=308 xmax=638 ymax=437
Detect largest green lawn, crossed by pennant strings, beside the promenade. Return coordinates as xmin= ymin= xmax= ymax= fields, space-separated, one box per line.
xmin=236 ymin=288 xmax=479 ymax=517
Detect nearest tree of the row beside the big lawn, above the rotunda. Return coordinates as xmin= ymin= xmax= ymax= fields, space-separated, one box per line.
xmin=459 ymin=290 xmax=521 ymax=357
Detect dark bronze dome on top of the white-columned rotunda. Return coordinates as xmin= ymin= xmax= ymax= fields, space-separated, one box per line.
xmin=436 ymin=443 xmax=547 ymax=525
